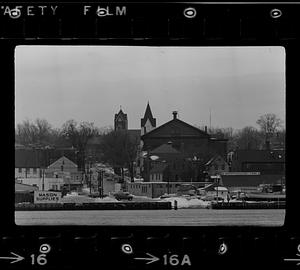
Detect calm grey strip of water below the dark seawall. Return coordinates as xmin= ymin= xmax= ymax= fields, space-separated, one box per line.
xmin=15 ymin=209 xmax=285 ymax=226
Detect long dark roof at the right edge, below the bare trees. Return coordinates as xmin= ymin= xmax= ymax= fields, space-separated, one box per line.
xmin=233 ymin=150 xmax=285 ymax=162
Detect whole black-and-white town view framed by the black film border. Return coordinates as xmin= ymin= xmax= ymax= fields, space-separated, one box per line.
xmin=14 ymin=45 xmax=286 ymax=226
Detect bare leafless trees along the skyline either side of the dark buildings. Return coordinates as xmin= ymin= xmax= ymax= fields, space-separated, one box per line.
xmin=15 ymin=114 xmax=285 ymax=177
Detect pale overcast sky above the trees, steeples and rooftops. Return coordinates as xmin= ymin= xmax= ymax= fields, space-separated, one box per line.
xmin=15 ymin=46 xmax=285 ymax=129
